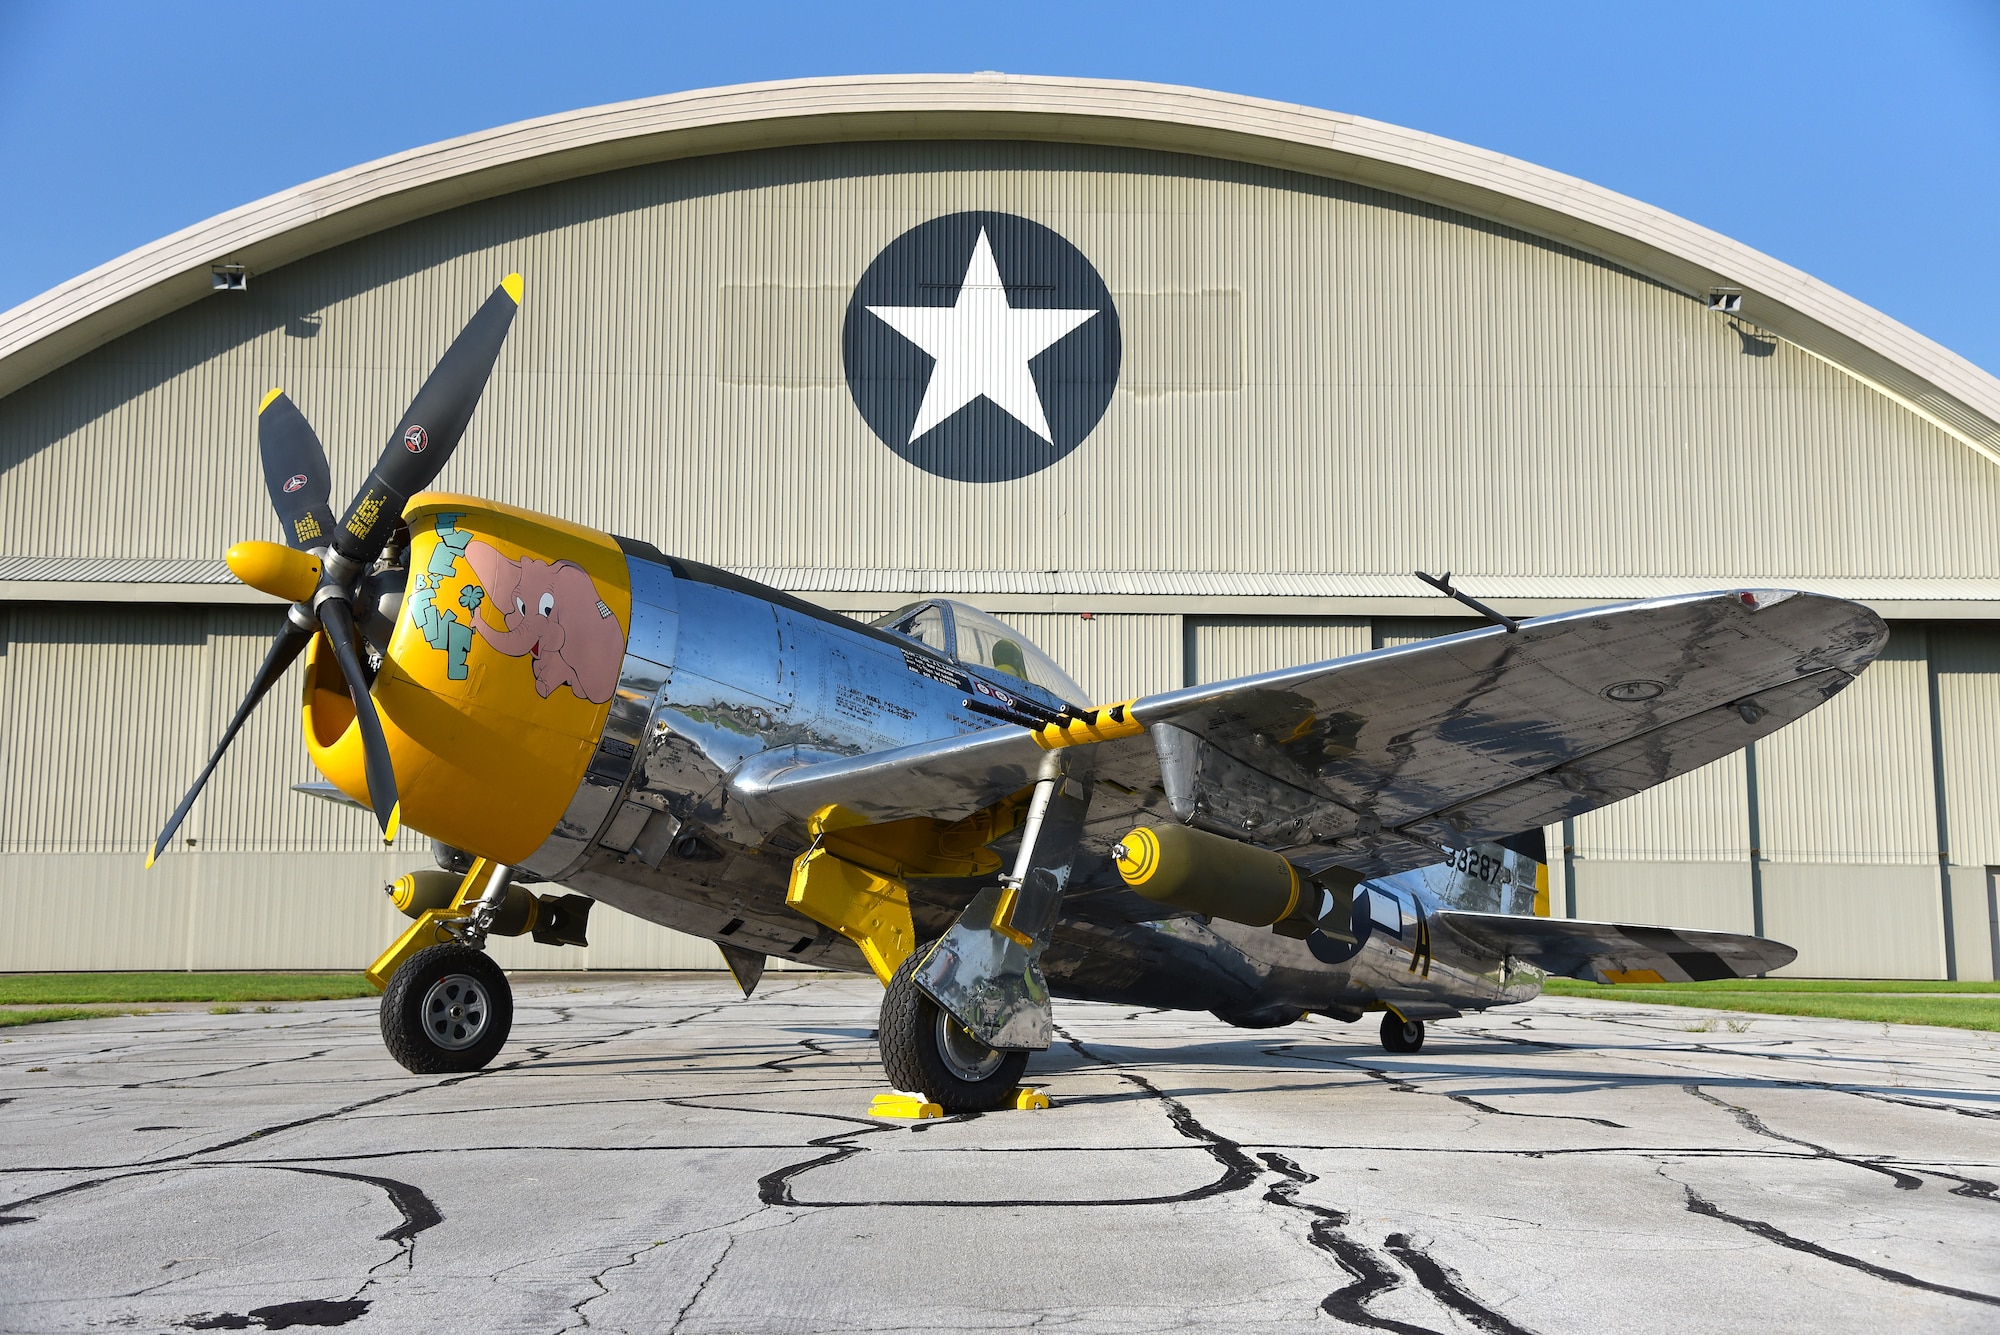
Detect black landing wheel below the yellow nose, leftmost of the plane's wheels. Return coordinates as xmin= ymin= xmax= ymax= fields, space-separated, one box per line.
xmin=382 ymin=945 xmax=514 ymax=1075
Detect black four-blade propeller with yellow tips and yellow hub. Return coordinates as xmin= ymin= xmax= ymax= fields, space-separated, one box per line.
xmin=146 ymin=274 xmax=520 ymax=867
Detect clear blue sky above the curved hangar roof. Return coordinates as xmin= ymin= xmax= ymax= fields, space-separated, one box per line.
xmin=0 ymin=0 xmax=2000 ymax=372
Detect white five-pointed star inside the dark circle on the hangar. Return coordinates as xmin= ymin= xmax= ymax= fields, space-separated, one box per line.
xmin=868 ymin=228 xmax=1098 ymax=444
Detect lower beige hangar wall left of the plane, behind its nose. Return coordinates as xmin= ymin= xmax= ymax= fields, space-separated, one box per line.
xmin=0 ymin=604 xmax=718 ymax=971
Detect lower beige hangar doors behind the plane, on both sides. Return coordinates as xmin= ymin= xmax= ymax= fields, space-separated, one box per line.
xmin=0 ymin=606 xmax=2000 ymax=977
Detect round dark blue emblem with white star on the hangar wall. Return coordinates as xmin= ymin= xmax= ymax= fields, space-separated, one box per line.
xmin=840 ymin=210 xmax=1122 ymax=482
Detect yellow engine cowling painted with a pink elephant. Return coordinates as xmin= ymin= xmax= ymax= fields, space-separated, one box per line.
xmin=304 ymin=492 xmax=632 ymax=863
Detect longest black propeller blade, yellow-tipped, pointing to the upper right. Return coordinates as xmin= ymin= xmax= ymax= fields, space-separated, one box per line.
xmin=334 ymin=274 xmax=520 ymax=566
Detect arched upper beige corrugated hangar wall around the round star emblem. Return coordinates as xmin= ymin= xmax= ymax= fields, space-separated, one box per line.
xmin=0 ymin=144 xmax=2000 ymax=582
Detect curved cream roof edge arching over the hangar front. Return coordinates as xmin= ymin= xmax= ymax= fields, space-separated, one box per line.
xmin=11 ymin=74 xmax=2000 ymax=453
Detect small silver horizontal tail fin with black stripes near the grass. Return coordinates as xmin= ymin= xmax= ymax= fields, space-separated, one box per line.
xmin=1438 ymin=909 xmax=1798 ymax=983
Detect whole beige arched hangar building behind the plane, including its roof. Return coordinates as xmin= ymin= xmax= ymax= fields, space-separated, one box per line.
xmin=0 ymin=76 xmax=2000 ymax=979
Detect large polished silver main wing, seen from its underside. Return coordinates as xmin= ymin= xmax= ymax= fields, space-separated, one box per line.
xmin=736 ymin=590 xmax=1888 ymax=875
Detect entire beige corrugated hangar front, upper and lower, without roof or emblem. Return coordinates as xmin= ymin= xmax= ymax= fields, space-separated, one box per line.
xmin=0 ymin=142 xmax=2000 ymax=975
